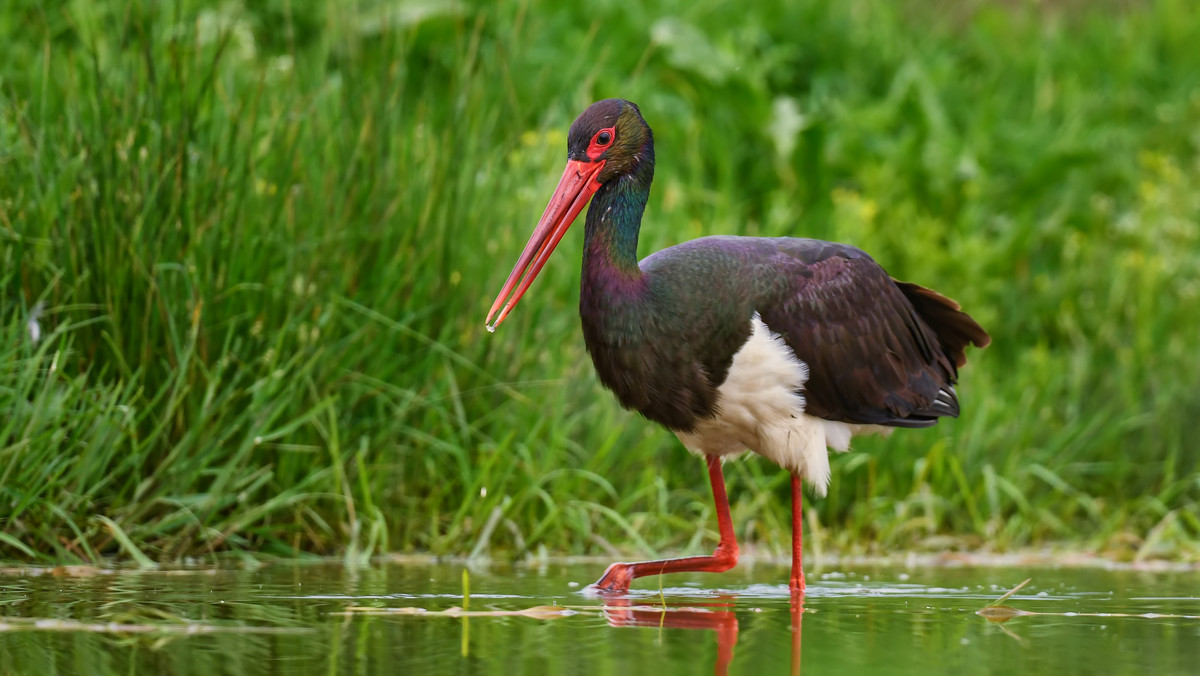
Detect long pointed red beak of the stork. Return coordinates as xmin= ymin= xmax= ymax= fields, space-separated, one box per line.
xmin=487 ymin=160 xmax=604 ymax=331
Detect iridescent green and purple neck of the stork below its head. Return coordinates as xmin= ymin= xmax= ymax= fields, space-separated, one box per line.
xmin=583 ymin=170 xmax=654 ymax=278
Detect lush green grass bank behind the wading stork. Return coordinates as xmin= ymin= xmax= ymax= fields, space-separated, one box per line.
xmin=0 ymin=0 xmax=1200 ymax=563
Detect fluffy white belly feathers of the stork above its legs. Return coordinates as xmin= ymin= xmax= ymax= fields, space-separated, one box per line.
xmin=677 ymin=315 xmax=892 ymax=496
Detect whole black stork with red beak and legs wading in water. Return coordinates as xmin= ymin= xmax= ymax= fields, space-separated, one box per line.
xmin=487 ymin=98 xmax=990 ymax=597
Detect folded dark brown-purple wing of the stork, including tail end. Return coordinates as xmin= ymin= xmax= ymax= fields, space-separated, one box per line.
xmin=757 ymin=240 xmax=989 ymax=427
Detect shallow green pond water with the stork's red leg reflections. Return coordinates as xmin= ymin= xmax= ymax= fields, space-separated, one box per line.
xmin=0 ymin=563 xmax=1200 ymax=676
